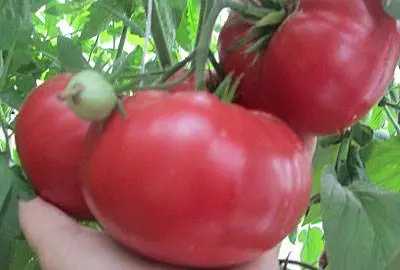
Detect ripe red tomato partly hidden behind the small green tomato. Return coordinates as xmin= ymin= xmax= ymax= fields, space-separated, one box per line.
xmin=15 ymin=74 xmax=93 ymax=219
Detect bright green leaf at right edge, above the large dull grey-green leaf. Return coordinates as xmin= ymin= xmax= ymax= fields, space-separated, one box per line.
xmin=365 ymin=137 xmax=400 ymax=192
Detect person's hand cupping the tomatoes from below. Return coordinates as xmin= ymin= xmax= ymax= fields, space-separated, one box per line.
xmin=19 ymin=138 xmax=316 ymax=270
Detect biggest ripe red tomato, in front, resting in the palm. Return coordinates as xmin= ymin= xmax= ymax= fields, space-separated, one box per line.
xmin=82 ymin=91 xmax=311 ymax=267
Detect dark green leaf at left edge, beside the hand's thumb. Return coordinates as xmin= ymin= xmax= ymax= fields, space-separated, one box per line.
xmin=0 ymin=154 xmax=19 ymax=270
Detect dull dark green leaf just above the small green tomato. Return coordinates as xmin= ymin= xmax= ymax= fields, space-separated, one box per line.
xmin=57 ymin=36 xmax=87 ymax=72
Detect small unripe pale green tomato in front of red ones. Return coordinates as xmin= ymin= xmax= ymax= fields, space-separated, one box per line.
xmin=58 ymin=70 xmax=118 ymax=121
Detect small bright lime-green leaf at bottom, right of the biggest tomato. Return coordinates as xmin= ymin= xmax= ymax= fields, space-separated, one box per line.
xmin=299 ymin=226 xmax=324 ymax=265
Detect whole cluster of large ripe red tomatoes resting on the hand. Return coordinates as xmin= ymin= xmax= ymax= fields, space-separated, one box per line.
xmin=16 ymin=0 xmax=399 ymax=268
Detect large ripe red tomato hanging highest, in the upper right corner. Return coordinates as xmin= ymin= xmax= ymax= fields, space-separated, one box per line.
xmin=219 ymin=0 xmax=400 ymax=135
